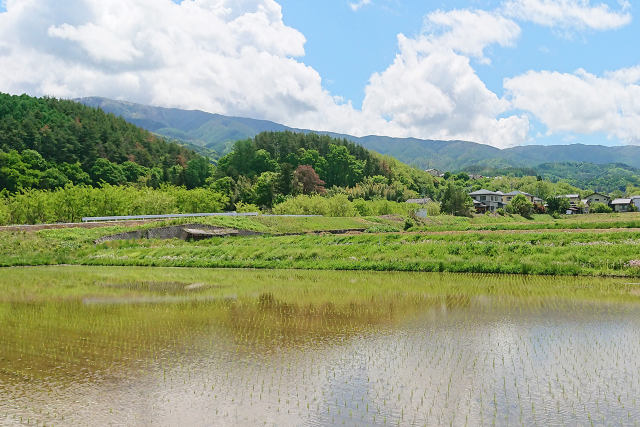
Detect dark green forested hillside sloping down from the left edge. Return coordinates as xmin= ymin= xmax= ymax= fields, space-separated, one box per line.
xmin=0 ymin=93 xmax=208 ymax=192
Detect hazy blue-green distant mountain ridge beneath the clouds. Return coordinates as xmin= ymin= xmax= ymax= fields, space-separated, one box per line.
xmin=76 ymin=97 xmax=640 ymax=171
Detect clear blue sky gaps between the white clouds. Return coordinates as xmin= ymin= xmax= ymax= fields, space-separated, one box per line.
xmin=280 ymin=0 xmax=640 ymax=106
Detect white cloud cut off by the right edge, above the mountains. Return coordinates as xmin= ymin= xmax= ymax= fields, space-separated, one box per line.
xmin=504 ymin=67 xmax=640 ymax=144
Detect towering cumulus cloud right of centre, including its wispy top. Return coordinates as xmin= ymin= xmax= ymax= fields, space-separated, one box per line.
xmin=362 ymin=10 xmax=529 ymax=147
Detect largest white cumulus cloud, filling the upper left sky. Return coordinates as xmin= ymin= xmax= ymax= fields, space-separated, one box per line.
xmin=0 ymin=0 xmax=382 ymax=131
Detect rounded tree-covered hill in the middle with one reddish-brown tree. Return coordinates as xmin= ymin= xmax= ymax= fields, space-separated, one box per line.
xmin=210 ymin=132 xmax=435 ymax=208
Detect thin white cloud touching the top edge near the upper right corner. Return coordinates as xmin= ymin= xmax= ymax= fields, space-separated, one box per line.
xmin=503 ymin=0 xmax=631 ymax=30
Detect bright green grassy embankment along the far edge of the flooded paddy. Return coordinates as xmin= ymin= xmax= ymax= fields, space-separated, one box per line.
xmin=0 ymin=214 xmax=640 ymax=277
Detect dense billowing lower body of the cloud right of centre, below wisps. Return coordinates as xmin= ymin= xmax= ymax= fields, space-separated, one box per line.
xmin=363 ymin=30 xmax=529 ymax=147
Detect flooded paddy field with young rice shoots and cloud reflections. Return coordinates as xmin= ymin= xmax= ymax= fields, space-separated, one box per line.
xmin=0 ymin=267 xmax=640 ymax=426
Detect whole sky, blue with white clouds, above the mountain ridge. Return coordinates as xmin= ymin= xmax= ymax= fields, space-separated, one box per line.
xmin=0 ymin=0 xmax=640 ymax=148
